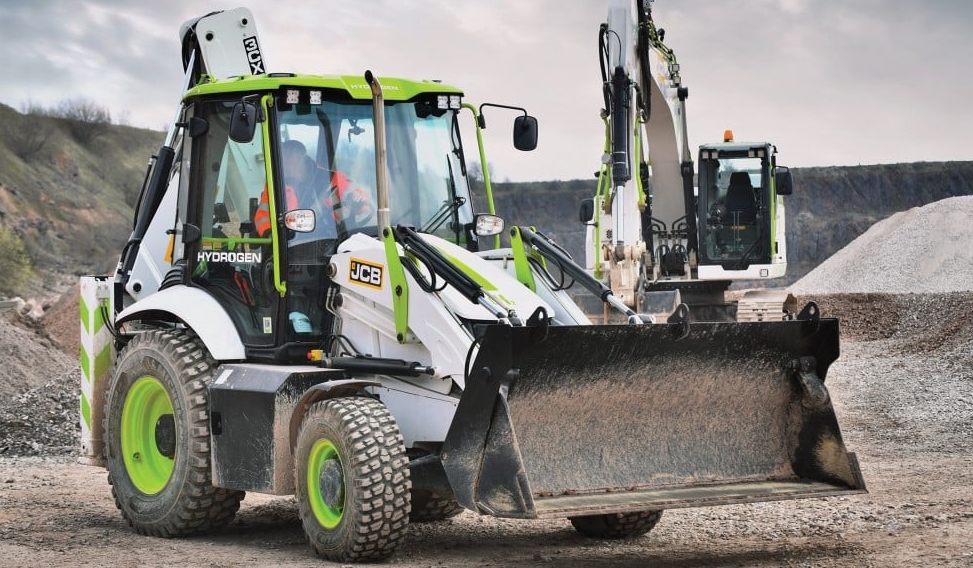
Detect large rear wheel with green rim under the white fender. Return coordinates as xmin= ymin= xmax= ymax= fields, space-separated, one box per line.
xmin=104 ymin=329 xmax=244 ymax=537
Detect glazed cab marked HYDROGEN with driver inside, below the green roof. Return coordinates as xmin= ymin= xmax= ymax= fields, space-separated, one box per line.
xmin=181 ymin=79 xmax=478 ymax=362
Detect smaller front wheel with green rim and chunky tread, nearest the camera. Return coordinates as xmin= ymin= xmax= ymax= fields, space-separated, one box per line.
xmin=294 ymin=397 xmax=412 ymax=562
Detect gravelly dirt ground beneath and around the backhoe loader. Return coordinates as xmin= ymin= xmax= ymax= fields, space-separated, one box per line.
xmin=0 ymin=294 xmax=973 ymax=568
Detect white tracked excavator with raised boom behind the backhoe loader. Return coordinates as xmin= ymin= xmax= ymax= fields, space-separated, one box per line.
xmin=581 ymin=0 xmax=796 ymax=321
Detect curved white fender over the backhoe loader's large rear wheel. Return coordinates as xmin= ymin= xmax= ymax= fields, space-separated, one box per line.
xmin=115 ymin=284 xmax=246 ymax=361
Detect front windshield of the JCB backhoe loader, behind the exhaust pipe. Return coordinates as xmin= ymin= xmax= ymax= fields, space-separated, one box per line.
xmin=278 ymin=101 xmax=473 ymax=243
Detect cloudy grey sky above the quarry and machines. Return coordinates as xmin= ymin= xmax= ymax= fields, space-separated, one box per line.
xmin=0 ymin=0 xmax=973 ymax=181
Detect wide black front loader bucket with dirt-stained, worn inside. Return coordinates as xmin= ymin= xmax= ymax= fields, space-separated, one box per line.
xmin=442 ymin=310 xmax=865 ymax=518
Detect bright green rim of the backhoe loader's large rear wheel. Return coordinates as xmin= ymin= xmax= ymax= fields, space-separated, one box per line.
xmin=121 ymin=377 xmax=175 ymax=495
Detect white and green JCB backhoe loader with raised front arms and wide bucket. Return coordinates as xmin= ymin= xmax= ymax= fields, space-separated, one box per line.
xmin=80 ymin=8 xmax=865 ymax=562
